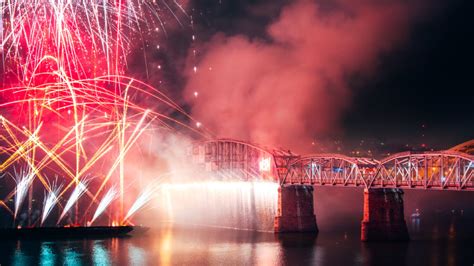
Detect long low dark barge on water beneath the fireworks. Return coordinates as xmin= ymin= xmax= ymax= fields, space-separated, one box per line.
xmin=0 ymin=225 xmax=135 ymax=239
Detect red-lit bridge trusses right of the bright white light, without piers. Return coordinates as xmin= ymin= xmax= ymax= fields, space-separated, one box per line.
xmin=281 ymin=151 xmax=474 ymax=190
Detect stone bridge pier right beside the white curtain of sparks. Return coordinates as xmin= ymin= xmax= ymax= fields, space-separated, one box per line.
xmin=274 ymin=185 xmax=318 ymax=233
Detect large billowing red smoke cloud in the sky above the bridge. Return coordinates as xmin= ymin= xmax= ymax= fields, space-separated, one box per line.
xmin=185 ymin=0 xmax=422 ymax=151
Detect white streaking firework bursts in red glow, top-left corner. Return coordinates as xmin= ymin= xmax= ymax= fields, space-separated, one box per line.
xmin=0 ymin=0 xmax=187 ymax=81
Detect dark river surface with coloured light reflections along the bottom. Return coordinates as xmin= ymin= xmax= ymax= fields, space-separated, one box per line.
xmin=0 ymin=227 xmax=474 ymax=265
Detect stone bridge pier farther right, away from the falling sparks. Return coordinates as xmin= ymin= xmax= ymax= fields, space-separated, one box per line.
xmin=361 ymin=188 xmax=409 ymax=241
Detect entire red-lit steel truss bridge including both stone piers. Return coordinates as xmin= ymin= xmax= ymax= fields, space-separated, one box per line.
xmin=192 ymin=139 xmax=474 ymax=241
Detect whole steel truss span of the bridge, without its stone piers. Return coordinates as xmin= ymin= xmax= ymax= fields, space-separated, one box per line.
xmin=192 ymin=139 xmax=474 ymax=191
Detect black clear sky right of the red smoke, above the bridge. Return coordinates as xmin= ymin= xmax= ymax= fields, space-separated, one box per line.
xmin=344 ymin=1 xmax=474 ymax=148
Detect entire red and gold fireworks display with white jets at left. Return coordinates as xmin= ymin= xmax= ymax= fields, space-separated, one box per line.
xmin=0 ymin=0 xmax=201 ymax=229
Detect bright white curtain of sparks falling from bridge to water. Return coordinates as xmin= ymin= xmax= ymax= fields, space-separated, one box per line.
xmin=158 ymin=181 xmax=278 ymax=231
